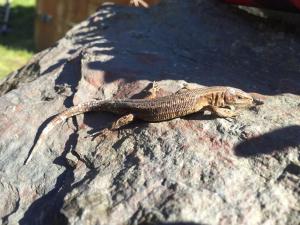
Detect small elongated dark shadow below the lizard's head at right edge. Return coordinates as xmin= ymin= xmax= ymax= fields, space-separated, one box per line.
xmin=235 ymin=125 xmax=300 ymax=157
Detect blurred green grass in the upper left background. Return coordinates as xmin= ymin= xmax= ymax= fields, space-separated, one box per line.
xmin=0 ymin=0 xmax=35 ymax=79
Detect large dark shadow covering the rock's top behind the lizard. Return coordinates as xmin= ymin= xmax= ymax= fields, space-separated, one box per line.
xmin=74 ymin=1 xmax=300 ymax=95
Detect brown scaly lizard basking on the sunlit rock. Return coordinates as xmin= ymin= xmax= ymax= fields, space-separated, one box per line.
xmin=24 ymin=82 xmax=253 ymax=165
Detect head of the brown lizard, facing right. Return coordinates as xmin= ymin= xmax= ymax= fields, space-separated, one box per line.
xmin=224 ymin=87 xmax=253 ymax=106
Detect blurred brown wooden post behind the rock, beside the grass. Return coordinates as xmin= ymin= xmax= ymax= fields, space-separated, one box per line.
xmin=35 ymin=0 xmax=159 ymax=50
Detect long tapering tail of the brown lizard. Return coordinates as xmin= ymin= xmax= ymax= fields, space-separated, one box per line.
xmin=24 ymin=100 xmax=109 ymax=165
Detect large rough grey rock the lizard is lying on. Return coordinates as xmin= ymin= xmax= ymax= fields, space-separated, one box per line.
xmin=0 ymin=0 xmax=300 ymax=225
